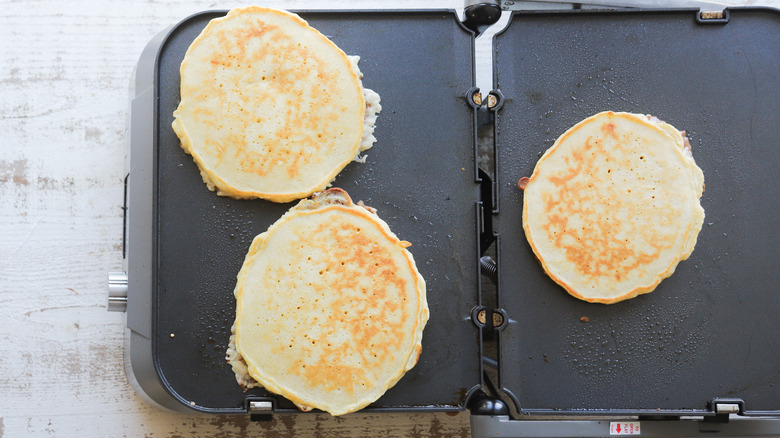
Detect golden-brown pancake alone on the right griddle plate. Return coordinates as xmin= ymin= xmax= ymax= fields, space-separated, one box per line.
xmin=521 ymin=111 xmax=704 ymax=304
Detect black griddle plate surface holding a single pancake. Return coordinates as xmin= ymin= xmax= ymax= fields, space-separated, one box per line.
xmin=494 ymin=9 xmax=780 ymax=415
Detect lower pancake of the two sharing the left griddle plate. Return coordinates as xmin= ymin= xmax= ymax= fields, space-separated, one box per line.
xmin=227 ymin=189 xmax=428 ymax=415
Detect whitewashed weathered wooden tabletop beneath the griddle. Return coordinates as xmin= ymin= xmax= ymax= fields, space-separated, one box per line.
xmin=0 ymin=0 xmax=780 ymax=438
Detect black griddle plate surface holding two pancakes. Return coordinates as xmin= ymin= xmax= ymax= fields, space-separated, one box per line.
xmin=153 ymin=11 xmax=480 ymax=412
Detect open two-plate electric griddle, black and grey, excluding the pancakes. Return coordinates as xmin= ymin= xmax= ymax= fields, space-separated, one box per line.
xmin=109 ymin=2 xmax=780 ymax=437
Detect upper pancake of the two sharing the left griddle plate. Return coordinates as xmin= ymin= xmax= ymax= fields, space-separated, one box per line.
xmin=172 ymin=7 xmax=381 ymax=202
